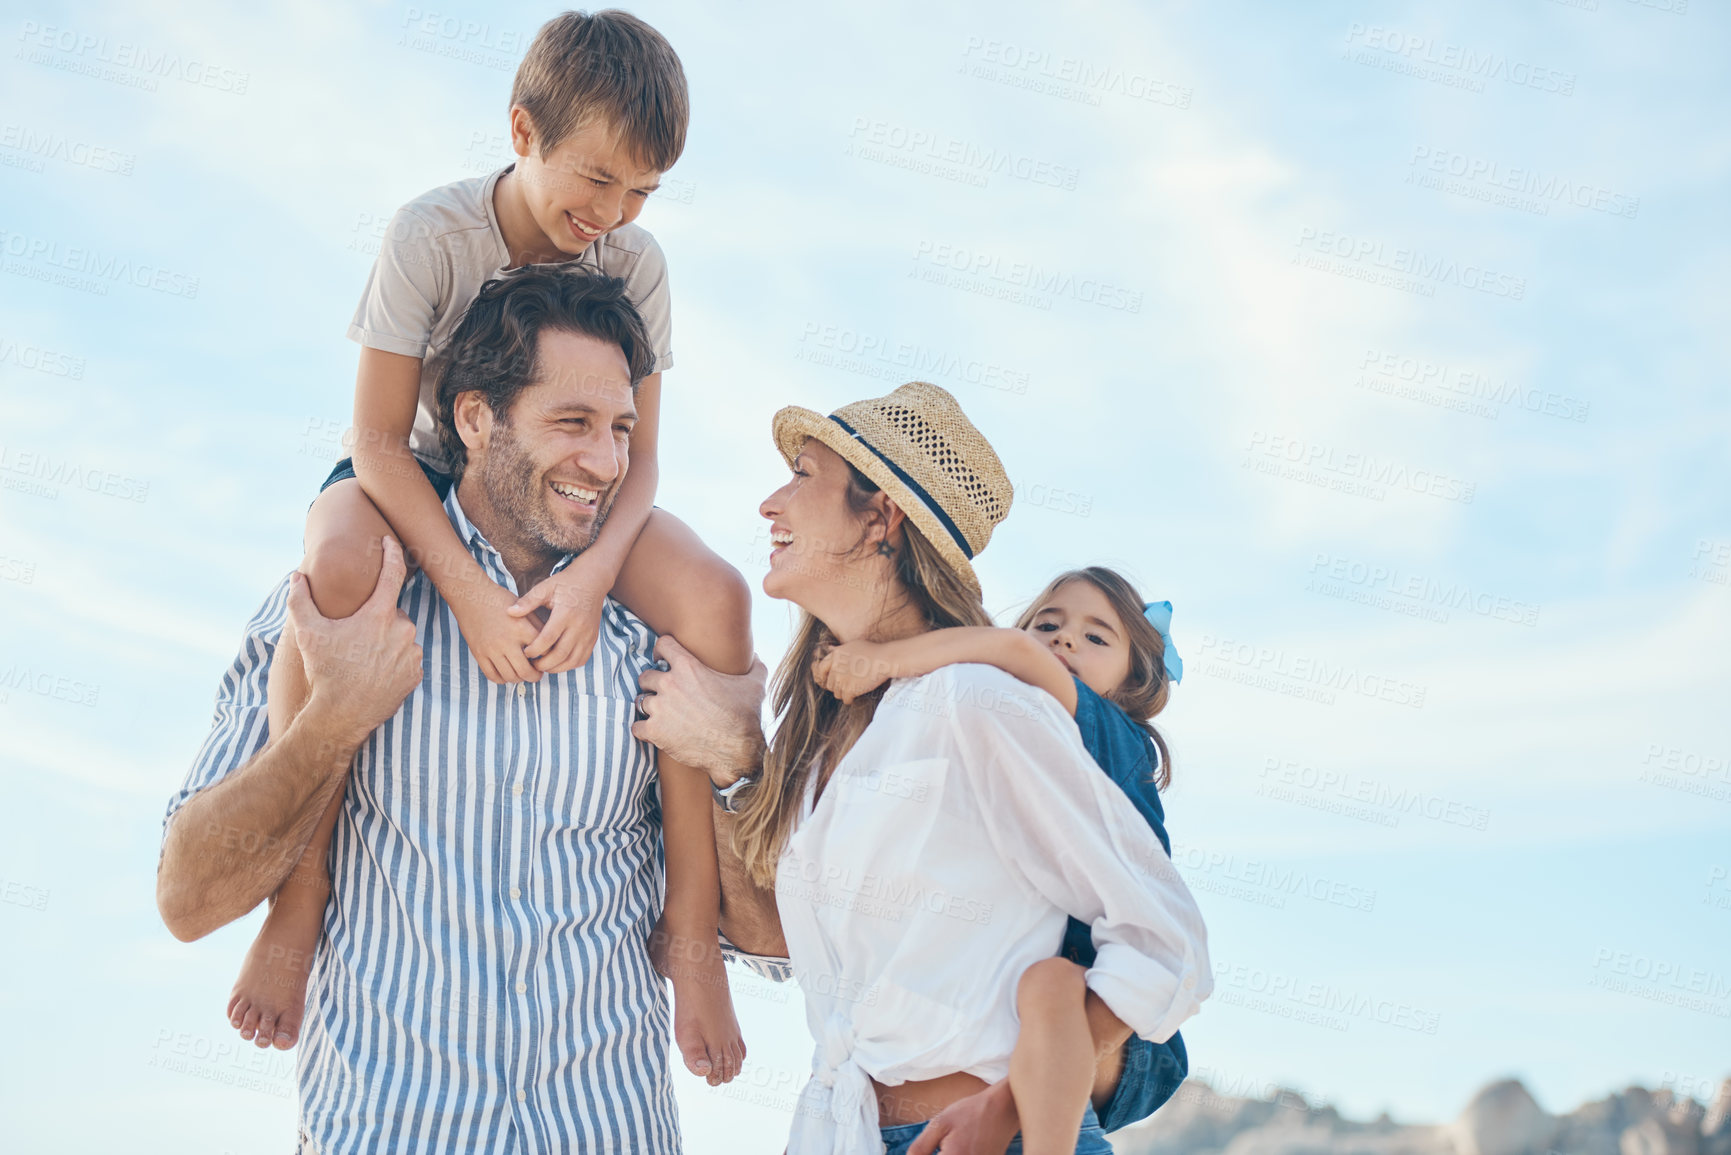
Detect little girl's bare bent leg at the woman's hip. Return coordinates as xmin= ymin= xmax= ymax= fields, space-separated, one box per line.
xmin=1009 ymin=958 xmax=1094 ymax=1155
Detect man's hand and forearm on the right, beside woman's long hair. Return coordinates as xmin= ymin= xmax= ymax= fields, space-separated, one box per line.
xmin=632 ymin=636 xmax=788 ymax=958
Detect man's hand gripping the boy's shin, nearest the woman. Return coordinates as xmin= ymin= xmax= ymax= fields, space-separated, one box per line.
xmin=632 ymin=636 xmax=769 ymax=786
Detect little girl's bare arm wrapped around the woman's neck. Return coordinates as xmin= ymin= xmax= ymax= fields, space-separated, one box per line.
xmin=812 ymin=625 xmax=1077 ymax=717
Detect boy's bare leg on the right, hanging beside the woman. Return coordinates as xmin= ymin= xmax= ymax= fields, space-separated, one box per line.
xmin=613 ymin=509 xmax=751 ymax=1086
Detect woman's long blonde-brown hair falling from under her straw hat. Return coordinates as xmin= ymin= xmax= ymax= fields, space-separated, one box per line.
xmin=732 ymin=464 xmax=992 ymax=887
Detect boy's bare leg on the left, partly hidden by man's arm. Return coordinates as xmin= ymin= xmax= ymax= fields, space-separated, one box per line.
xmin=228 ymin=480 xmax=391 ymax=1049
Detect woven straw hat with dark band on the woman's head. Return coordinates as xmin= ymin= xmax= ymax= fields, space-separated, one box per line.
xmin=774 ymin=381 xmax=1013 ymax=597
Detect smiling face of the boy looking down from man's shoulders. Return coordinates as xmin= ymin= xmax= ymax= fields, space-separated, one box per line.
xmin=511 ymin=106 xmax=661 ymax=256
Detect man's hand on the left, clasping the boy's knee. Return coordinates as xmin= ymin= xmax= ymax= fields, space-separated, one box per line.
xmin=287 ymin=537 xmax=421 ymax=736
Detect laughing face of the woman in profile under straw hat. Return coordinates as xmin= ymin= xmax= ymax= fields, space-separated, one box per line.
xmin=758 ymin=438 xmax=879 ymax=609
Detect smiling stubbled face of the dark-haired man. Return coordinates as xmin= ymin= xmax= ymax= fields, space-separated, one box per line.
xmin=469 ymin=331 xmax=637 ymax=554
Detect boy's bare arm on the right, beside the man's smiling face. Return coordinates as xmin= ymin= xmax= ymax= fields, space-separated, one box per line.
xmin=511 ymin=372 xmax=661 ymax=674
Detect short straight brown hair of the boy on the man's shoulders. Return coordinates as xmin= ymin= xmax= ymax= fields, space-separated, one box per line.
xmin=511 ymin=9 xmax=691 ymax=173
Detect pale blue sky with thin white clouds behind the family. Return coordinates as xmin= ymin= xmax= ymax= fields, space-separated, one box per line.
xmin=0 ymin=0 xmax=1731 ymax=1153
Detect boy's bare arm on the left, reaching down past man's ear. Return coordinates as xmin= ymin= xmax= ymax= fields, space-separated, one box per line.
xmin=353 ymin=346 xmax=540 ymax=682
